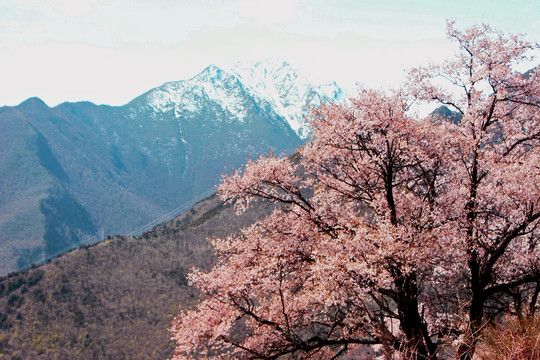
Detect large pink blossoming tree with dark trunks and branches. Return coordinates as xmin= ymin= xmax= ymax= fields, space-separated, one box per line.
xmin=172 ymin=23 xmax=540 ymax=359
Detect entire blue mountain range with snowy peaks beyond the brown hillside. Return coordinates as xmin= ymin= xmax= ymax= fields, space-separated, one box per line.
xmin=0 ymin=62 xmax=343 ymax=275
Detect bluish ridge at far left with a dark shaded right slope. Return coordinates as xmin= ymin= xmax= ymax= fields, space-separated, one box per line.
xmin=0 ymin=99 xmax=96 ymax=274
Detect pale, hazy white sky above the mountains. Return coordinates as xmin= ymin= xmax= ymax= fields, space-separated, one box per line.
xmin=0 ymin=0 xmax=540 ymax=106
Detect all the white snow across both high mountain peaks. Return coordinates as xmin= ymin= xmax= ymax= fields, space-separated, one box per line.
xmin=137 ymin=60 xmax=345 ymax=139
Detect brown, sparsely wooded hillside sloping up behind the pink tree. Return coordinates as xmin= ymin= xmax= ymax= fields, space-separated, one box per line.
xmin=0 ymin=197 xmax=269 ymax=360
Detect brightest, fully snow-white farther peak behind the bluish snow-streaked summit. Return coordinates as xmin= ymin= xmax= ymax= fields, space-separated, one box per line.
xmin=226 ymin=60 xmax=345 ymax=139
